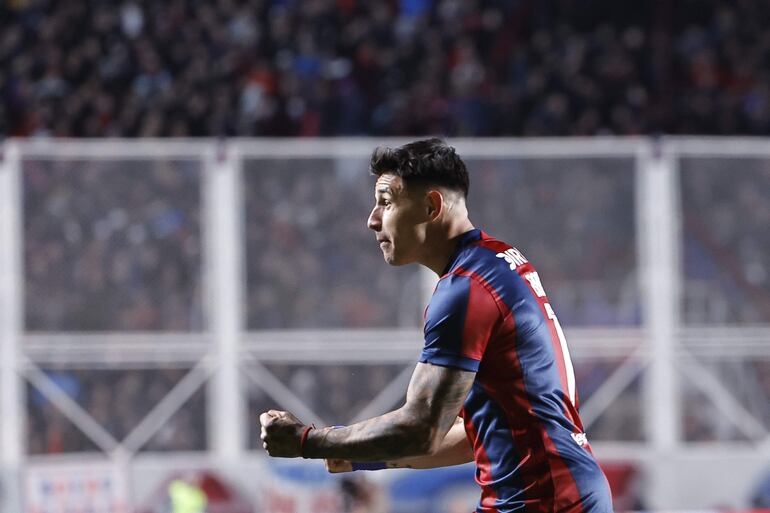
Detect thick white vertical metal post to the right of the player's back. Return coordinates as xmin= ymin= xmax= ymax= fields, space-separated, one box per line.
xmin=636 ymin=142 xmax=681 ymax=508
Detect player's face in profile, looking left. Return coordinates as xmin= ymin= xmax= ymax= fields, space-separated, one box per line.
xmin=367 ymin=173 xmax=427 ymax=265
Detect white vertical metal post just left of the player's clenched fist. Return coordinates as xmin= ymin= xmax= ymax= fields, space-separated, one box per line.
xmin=203 ymin=145 xmax=246 ymax=461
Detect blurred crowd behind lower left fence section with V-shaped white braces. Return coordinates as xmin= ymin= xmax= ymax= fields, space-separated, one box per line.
xmin=26 ymin=369 xmax=206 ymax=454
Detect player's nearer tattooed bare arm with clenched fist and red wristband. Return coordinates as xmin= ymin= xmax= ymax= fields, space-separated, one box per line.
xmin=260 ymin=363 xmax=476 ymax=461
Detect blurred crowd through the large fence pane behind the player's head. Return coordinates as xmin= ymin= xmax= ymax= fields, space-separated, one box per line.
xmin=245 ymin=154 xmax=640 ymax=329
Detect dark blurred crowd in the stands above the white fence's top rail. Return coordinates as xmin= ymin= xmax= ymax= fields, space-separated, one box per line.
xmin=0 ymin=0 xmax=770 ymax=137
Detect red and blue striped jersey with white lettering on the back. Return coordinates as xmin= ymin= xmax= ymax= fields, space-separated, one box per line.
xmin=420 ymin=230 xmax=612 ymax=513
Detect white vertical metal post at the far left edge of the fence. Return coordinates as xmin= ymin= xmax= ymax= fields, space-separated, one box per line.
xmin=0 ymin=142 xmax=24 ymax=506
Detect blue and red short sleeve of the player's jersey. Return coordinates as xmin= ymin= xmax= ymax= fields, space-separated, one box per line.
xmin=420 ymin=275 xmax=500 ymax=372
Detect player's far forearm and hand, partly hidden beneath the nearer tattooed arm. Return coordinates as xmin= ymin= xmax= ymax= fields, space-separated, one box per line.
xmin=326 ymin=417 xmax=473 ymax=474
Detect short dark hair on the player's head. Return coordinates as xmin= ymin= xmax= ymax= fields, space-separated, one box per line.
xmin=369 ymin=138 xmax=470 ymax=198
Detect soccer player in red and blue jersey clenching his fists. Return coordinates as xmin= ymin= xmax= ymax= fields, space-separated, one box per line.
xmin=260 ymin=139 xmax=612 ymax=513
